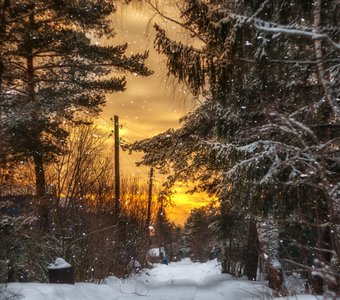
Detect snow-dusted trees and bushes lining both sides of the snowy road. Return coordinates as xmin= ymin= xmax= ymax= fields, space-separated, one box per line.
xmin=0 ymin=0 xmax=340 ymax=299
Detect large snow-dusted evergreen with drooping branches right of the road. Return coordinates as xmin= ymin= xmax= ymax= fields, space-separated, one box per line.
xmin=130 ymin=0 xmax=340 ymax=292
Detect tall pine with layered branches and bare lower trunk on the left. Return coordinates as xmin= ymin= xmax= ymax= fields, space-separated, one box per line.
xmin=1 ymin=0 xmax=151 ymax=200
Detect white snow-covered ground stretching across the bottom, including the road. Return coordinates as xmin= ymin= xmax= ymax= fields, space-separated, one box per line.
xmin=3 ymin=259 xmax=315 ymax=300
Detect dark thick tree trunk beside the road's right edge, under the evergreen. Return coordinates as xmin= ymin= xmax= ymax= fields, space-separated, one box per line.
xmin=245 ymin=217 xmax=259 ymax=280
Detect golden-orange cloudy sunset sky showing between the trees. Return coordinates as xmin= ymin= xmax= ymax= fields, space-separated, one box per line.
xmin=98 ymin=5 xmax=211 ymax=224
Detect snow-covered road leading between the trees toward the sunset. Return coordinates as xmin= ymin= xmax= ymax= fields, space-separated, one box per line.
xmin=108 ymin=260 xmax=261 ymax=300
